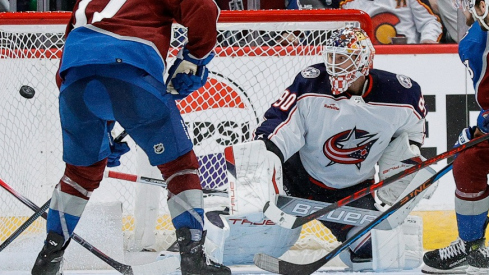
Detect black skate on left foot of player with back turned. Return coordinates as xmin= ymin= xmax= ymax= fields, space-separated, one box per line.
xmin=32 ymin=233 xmax=66 ymax=275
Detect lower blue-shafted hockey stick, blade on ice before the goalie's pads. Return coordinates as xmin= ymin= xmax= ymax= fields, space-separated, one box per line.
xmin=253 ymin=163 xmax=452 ymax=275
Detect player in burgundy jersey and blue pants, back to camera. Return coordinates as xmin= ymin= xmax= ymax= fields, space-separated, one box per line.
xmin=32 ymin=0 xmax=231 ymax=275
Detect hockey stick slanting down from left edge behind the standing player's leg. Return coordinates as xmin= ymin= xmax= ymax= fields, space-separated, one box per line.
xmin=0 ymin=179 xmax=180 ymax=275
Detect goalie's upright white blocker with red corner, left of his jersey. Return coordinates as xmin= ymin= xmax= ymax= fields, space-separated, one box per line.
xmin=224 ymin=140 xmax=284 ymax=222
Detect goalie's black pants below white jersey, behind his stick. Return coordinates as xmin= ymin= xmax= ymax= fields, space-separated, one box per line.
xmin=283 ymin=153 xmax=377 ymax=242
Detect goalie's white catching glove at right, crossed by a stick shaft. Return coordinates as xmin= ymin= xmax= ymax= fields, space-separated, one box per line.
xmin=377 ymin=132 xmax=425 ymax=206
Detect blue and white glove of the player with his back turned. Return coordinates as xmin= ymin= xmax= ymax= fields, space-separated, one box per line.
xmin=166 ymin=47 xmax=214 ymax=99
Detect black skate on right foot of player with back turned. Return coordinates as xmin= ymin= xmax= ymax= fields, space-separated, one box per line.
xmin=176 ymin=228 xmax=231 ymax=275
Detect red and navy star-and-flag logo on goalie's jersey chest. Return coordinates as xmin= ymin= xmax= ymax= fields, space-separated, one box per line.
xmin=323 ymin=127 xmax=378 ymax=169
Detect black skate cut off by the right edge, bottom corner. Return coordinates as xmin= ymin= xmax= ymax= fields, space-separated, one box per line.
xmin=467 ymin=238 xmax=489 ymax=275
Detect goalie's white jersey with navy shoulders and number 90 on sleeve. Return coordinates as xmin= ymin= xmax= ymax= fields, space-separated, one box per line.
xmin=255 ymin=63 xmax=426 ymax=189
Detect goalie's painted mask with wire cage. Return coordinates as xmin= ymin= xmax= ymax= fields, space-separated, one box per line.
xmin=323 ymin=28 xmax=375 ymax=95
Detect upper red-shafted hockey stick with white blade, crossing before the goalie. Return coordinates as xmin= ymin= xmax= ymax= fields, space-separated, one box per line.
xmin=263 ymin=134 xmax=489 ymax=229
